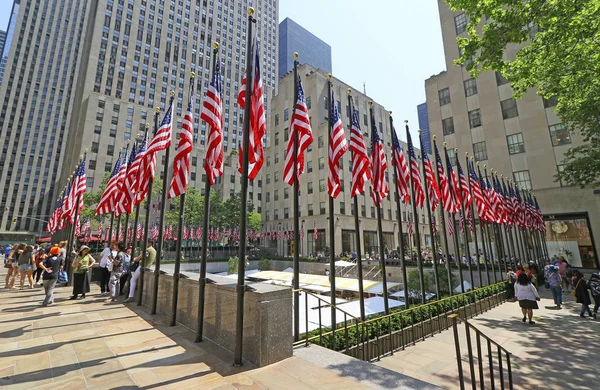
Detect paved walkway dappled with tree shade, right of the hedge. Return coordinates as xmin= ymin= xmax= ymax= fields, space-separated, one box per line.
xmin=376 ymin=287 xmax=600 ymax=390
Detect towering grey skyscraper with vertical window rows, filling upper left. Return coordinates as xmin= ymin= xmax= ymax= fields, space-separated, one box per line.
xmin=0 ymin=0 xmax=278 ymax=231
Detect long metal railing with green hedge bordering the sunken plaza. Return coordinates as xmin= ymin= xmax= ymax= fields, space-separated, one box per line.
xmin=294 ymin=282 xmax=505 ymax=362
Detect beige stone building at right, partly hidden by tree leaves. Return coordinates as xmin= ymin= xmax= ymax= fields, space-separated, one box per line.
xmin=425 ymin=0 xmax=600 ymax=268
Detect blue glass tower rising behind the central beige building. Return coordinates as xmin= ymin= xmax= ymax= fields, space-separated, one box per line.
xmin=278 ymin=18 xmax=332 ymax=78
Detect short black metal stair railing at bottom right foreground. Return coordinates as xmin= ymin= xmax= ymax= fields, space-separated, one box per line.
xmin=448 ymin=314 xmax=513 ymax=390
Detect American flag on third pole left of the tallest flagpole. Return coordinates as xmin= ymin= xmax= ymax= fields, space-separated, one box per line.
xmin=135 ymin=102 xmax=172 ymax=206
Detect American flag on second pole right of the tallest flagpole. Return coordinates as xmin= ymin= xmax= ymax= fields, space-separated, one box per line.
xmin=327 ymin=91 xmax=348 ymax=199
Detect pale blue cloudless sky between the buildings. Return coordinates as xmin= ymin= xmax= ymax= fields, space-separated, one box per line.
xmin=0 ymin=0 xmax=445 ymax=139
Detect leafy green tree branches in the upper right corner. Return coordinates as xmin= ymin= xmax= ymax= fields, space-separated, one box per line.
xmin=446 ymin=0 xmax=600 ymax=187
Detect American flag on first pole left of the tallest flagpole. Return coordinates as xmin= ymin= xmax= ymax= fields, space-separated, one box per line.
xmin=200 ymin=55 xmax=223 ymax=185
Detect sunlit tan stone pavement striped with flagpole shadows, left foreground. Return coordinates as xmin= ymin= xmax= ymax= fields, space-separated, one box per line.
xmin=0 ymin=275 xmax=435 ymax=390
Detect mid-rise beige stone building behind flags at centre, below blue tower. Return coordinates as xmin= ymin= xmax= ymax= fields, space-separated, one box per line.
xmin=262 ymin=64 xmax=431 ymax=256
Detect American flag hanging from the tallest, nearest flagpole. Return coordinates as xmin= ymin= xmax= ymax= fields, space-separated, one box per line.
xmin=238 ymin=40 xmax=267 ymax=180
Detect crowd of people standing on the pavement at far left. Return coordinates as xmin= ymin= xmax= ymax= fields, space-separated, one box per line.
xmin=2 ymin=240 xmax=156 ymax=306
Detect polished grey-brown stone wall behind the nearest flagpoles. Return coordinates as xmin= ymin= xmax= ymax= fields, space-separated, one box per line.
xmin=143 ymin=271 xmax=293 ymax=367
